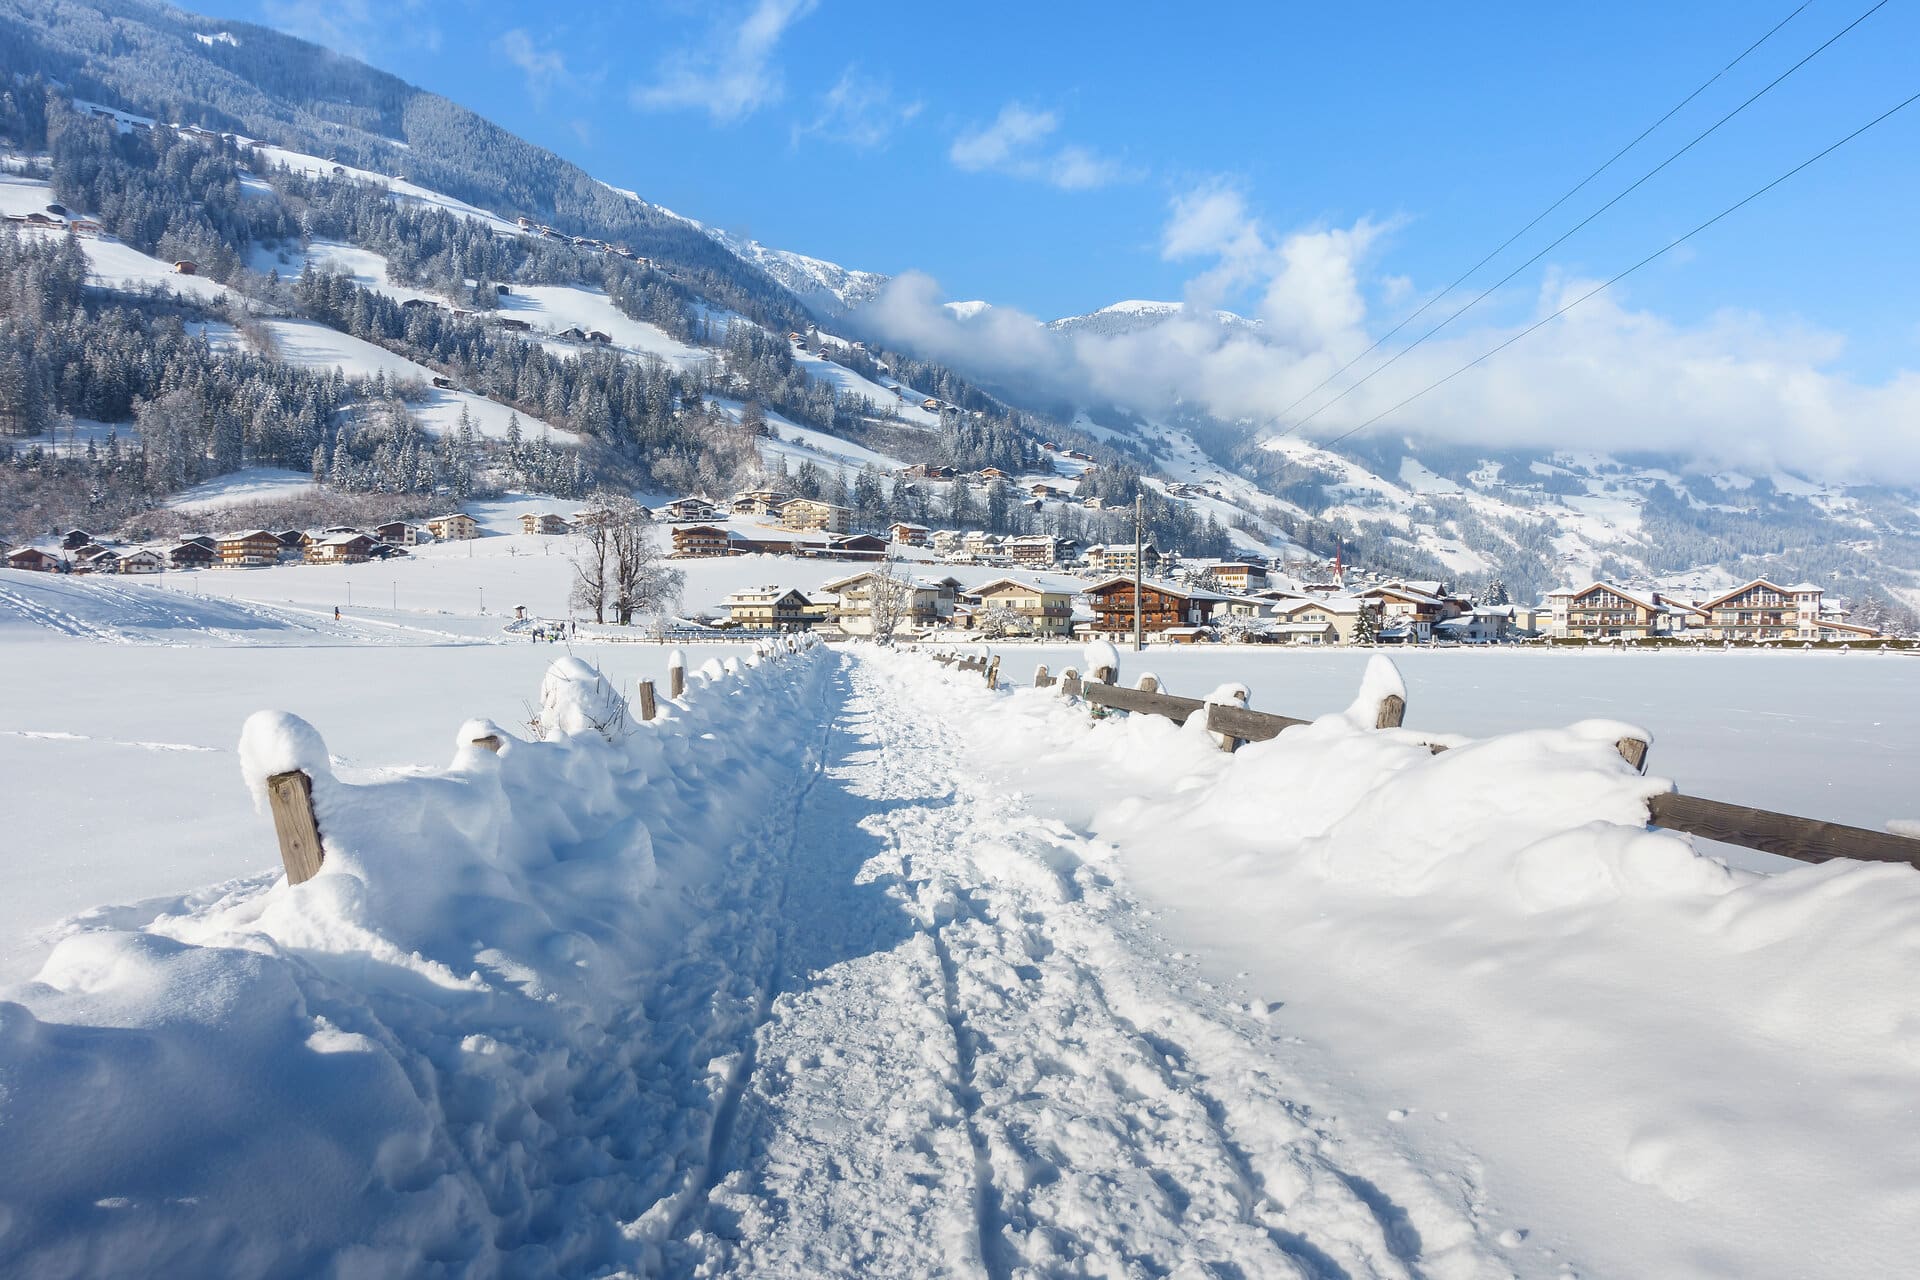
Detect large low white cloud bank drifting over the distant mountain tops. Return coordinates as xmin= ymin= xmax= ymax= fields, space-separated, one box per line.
xmin=864 ymin=184 xmax=1920 ymax=484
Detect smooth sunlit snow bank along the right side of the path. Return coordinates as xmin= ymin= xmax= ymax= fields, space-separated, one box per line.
xmin=889 ymin=654 xmax=1920 ymax=1278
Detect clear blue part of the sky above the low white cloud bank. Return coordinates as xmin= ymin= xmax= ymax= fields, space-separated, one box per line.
xmin=191 ymin=0 xmax=1920 ymax=353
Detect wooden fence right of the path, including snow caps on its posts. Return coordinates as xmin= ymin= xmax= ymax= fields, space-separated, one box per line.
xmin=913 ymin=645 xmax=1920 ymax=867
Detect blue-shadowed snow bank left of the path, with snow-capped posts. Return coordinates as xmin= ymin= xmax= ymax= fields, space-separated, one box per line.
xmin=0 ymin=654 xmax=829 ymax=1274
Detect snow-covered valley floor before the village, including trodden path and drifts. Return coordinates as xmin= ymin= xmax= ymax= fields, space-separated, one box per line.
xmin=0 ymin=571 xmax=1920 ymax=1280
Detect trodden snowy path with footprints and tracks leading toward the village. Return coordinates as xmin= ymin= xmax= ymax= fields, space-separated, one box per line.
xmin=672 ymin=660 xmax=1511 ymax=1278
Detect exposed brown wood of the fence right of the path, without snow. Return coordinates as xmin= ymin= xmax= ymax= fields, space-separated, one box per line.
xmin=941 ymin=658 xmax=1920 ymax=869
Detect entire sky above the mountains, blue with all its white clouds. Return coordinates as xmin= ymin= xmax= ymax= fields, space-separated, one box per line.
xmin=187 ymin=0 xmax=1920 ymax=478
